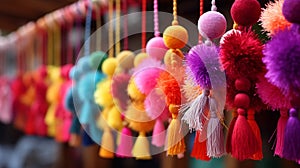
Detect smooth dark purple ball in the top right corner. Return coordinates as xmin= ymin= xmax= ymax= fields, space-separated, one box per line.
xmin=282 ymin=0 xmax=300 ymax=24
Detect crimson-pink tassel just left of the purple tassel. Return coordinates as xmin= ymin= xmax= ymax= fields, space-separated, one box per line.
xmin=274 ymin=110 xmax=288 ymax=158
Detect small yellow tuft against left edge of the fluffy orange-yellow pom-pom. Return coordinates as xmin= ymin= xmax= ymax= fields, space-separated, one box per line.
xmin=107 ymin=106 xmax=123 ymax=130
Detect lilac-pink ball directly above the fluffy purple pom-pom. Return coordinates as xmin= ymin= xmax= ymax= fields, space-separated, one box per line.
xmin=198 ymin=11 xmax=227 ymax=40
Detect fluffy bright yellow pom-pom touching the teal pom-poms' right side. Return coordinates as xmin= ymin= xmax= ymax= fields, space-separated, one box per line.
xmin=94 ymin=79 xmax=113 ymax=107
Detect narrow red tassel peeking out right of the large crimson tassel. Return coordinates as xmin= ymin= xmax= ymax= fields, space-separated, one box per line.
xmin=247 ymin=110 xmax=263 ymax=160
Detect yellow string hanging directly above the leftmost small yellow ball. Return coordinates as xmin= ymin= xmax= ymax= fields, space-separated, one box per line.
xmin=108 ymin=0 xmax=114 ymax=58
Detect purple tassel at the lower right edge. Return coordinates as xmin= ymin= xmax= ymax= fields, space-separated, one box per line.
xmin=283 ymin=108 xmax=300 ymax=161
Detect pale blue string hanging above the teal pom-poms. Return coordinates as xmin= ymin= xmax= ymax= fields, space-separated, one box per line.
xmin=84 ymin=0 xmax=93 ymax=56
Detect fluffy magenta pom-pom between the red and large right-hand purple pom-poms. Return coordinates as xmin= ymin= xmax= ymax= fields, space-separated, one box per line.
xmin=256 ymin=75 xmax=291 ymax=110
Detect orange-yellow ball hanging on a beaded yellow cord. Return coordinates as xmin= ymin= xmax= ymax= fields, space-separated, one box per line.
xmin=163 ymin=25 xmax=188 ymax=49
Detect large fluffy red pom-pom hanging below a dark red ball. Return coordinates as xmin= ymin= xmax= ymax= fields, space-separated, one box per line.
xmin=220 ymin=30 xmax=264 ymax=80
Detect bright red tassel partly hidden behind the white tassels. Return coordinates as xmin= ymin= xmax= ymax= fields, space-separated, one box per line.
xmin=191 ymin=130 xmax=210 ymax=161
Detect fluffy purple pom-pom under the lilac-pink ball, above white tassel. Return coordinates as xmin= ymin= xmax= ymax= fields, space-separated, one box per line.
xmin=186 ymin=44 xmax=222 ymax=89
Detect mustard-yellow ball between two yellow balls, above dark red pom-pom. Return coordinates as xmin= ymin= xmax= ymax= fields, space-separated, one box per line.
xmin=117 ymin=50 xmax=134 ymax=71
